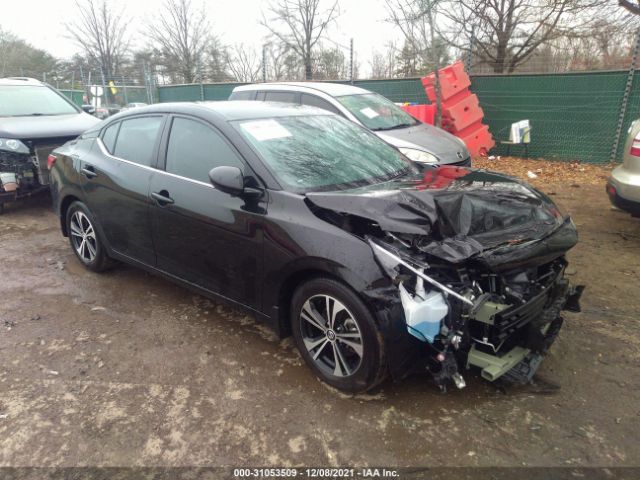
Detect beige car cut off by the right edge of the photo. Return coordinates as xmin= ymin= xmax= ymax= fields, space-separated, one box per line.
xmin=607 ymin=119 xmax=640 ymax=217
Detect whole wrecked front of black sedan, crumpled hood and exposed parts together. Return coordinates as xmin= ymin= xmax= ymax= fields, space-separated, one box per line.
xmin=308 ymin=167 xmax=584 ymax=388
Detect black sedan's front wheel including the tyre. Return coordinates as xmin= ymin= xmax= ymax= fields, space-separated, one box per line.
xmin=291 ymin=278 xmax=386 ymax=393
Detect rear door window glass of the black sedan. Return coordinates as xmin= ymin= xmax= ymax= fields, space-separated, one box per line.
xmin=112 ymin=116 xmax=162 ymax=167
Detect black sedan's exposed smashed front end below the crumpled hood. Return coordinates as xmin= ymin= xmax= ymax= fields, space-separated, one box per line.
xmin=369 ymin=238 xmax=584 ymax=390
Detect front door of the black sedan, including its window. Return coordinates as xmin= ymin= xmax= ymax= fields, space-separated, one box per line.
xmin=150 ymin=116 xmax=265 ymax=308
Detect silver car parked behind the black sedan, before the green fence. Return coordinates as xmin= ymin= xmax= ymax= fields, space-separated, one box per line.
xmin=229 ymin=82 xmax=471 ymax=166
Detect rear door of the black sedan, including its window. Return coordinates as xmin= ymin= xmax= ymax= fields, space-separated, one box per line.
xmin=81 ymin=115 xmax=165 ymax=265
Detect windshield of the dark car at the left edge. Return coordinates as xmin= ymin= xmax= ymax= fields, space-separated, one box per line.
xmin=0 ymin=85 xmax=78 ymax=117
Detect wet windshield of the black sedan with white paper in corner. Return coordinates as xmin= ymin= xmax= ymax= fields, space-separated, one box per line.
xmin=233 ymin=115 xmax=415 ymax=193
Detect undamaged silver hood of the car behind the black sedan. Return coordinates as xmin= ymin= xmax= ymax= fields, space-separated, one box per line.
xmin=374 ymin=123 xmax=469 ymax=163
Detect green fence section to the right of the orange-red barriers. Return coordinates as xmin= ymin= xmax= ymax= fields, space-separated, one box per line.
xmin=472 ymin=72 xmax=640 ymax=163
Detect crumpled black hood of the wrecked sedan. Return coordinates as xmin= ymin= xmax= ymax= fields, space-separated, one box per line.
xmin=307 ymin=166 xmax=577 ymax=270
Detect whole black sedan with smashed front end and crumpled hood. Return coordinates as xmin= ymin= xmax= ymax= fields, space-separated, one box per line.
xmin=51 ymin=102 xmax=581 ymax=392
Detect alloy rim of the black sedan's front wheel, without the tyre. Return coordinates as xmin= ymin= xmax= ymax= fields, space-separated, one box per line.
xmin=300 ymin=295 xmax=363 ymax=377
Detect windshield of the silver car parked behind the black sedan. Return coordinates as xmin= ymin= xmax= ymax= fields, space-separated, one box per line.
xmin=336 ymin=93 xmax=420 ymax=130
